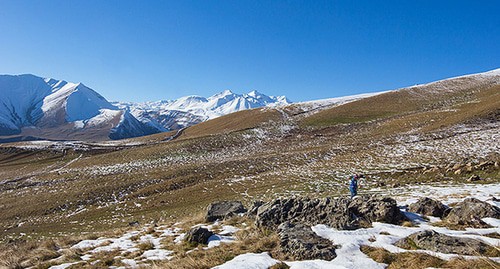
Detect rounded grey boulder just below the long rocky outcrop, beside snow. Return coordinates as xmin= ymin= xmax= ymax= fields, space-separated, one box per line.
xmin=278 ymin=221 xmax=337 ymax=261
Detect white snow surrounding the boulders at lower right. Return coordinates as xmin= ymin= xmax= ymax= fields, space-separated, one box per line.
xmin=214 ymin=183 xmax=500 ymax=269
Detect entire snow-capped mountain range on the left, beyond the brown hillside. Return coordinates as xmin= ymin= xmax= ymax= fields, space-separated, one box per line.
xmin=0 ymin=75 xmax=290 ymax=142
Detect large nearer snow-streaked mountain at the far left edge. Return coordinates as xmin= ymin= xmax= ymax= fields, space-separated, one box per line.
xmin=0 ymin=75 xmax=160 ymax=139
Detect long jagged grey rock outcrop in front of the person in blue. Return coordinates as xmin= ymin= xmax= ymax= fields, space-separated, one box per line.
xmin=256 ymin=196 xmax=405 ymax=230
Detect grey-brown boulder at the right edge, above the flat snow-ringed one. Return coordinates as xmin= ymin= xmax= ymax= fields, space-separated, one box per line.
xmin=444 ymin=198 xmax=500 ymax=227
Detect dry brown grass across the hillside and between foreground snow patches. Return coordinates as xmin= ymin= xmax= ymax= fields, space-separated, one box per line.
xmin=0 ymin=74 xmax=500 ymax=268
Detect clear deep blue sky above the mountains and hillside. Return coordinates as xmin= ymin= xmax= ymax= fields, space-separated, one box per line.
xmin=0 ymin=0 xmax=500 ymax=101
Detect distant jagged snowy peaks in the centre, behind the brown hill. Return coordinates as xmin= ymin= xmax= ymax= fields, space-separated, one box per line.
xmin=113 ymin=90 xmax=291 ymax=130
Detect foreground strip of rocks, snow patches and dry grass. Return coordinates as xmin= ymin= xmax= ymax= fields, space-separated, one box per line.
xmin=4 ymin=183 xmax=500 ymax=269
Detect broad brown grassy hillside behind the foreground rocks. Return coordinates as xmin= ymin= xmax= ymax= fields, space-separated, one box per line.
xmin=0 ymin=70 xmax=500 ymax=249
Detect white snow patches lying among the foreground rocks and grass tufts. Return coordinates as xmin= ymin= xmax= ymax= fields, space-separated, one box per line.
xmin=44 ymin=183 xmax=500 ymax=269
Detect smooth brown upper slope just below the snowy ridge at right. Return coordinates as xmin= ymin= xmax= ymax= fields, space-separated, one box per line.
xmin=301 ymin=77 xmax=500 ymax=131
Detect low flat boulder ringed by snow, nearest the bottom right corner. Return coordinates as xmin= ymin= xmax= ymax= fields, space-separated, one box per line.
xmin=395 ymin=230 xmax=500 ymax=257
